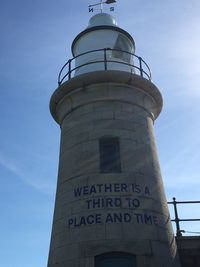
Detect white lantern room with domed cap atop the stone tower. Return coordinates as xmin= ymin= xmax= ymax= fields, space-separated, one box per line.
xmin=72 ymin=13 xmax=135 ymax=76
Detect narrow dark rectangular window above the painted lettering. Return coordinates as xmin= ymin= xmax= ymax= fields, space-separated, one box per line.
xmin=99 ymin=137 xmax=121 ymax=173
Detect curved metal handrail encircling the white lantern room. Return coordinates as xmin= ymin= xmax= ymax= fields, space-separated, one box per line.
xmin=58 ymin=48 xmax=151 ymax=86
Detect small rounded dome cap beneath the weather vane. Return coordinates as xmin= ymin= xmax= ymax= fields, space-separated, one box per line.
xmin=88 ymin=13 xmax=117 ymax=28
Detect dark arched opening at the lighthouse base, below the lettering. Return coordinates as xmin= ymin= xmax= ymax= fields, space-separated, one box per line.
xmin=95 ymin=252 xmax=137 ymax=267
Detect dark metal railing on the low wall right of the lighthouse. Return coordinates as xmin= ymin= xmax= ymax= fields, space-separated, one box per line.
xmin=168 ymin=197 xmax=200 ymax=236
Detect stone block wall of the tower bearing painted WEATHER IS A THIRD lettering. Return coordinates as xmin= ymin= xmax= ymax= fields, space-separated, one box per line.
xmin=48 ymin=71 xmax=179 ymax=267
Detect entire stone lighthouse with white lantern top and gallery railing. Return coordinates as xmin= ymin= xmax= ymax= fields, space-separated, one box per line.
xmin=48 ymin=13 xmax=179 ymax=267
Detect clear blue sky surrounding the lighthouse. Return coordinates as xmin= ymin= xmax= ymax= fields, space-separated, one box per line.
xmin=0 ymin=0 xmax=200 ymax=267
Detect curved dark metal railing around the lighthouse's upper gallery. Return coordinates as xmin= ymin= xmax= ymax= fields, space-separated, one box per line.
xmin=58 ymin=48 xmax=151 ymax=86
